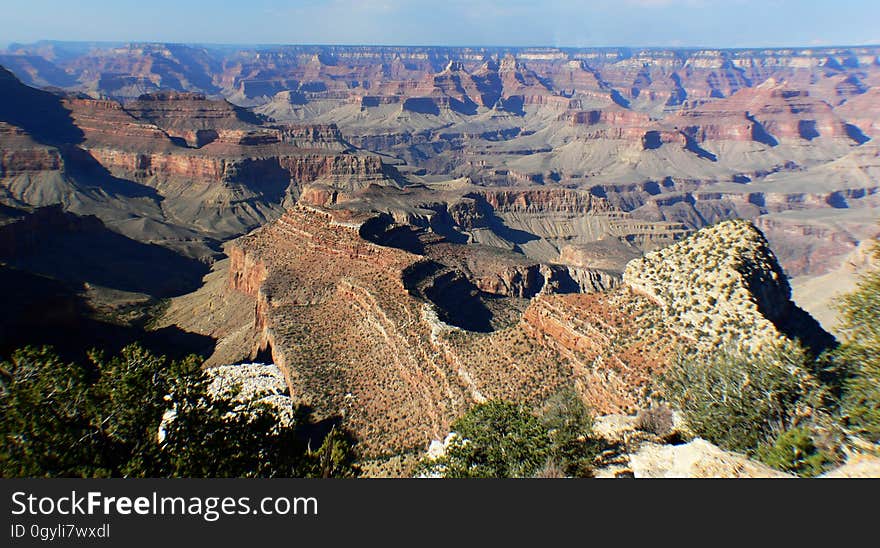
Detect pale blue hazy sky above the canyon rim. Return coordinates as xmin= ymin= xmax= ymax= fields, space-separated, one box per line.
xmin=0 ymin=0 xmax=880 ymax=47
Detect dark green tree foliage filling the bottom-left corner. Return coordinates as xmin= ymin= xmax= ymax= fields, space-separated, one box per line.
xmin=0 ymin=345 xmax=357 ymax=477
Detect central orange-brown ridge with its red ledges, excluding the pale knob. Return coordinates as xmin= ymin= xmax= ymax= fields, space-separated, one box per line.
xmin=220 ymin=206 xmax=648 ymax=456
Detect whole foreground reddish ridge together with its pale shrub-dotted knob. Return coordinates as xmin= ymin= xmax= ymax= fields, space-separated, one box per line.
xmin=160 ymin=197 xmax=832 ymax=458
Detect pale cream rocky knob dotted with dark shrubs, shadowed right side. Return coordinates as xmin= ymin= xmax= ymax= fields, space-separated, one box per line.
xmin=623 ymin=221 xmax=833 ymax=349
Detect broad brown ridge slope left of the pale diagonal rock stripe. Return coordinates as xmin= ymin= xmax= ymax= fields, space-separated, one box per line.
xmin=228 ymin=207 xmax=460 ymax=454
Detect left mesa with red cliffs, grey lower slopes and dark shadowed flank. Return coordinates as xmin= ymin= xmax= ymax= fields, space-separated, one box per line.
xmin=0 ymin=65 xmax=397 ymax=259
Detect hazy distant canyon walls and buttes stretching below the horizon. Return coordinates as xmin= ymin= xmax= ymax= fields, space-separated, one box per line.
xmin=0 ymin=42 xmax=880 ymax=294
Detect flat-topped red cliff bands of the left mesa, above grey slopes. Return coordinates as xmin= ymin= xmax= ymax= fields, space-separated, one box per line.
xmin=56 ymin=93 xmax=386 ymax=190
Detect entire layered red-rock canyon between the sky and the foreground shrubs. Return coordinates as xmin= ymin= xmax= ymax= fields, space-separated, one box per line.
xmin=0 ymin=42 xmax=880 ymax=470
